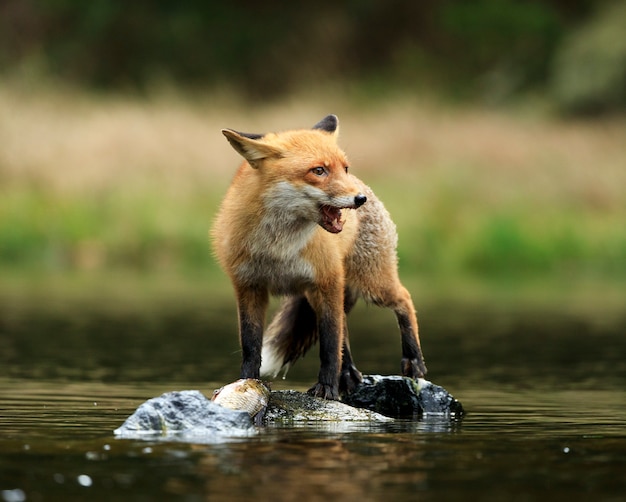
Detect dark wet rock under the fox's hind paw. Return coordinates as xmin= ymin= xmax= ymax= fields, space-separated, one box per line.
xmin=343 ymin=375 xmax=464 ymax=418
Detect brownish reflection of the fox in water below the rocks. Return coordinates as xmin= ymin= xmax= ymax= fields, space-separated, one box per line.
xmin=191 ymin=435 xmax=428 ymax=500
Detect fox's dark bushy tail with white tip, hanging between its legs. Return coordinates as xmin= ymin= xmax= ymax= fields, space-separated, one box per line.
xmin=261 ymin=296 xmax=318 ymax=378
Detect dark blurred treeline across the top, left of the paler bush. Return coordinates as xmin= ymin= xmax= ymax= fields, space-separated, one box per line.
xmin=0 ymin=0 xmax=610 ymax=111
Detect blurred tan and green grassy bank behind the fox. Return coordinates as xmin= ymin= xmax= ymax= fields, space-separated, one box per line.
xmin=0 ymin=82 xmax=626 ymax=279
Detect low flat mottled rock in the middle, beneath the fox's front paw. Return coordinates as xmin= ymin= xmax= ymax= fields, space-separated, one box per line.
xmin=264 ymin=390 xmax=393 ymax=424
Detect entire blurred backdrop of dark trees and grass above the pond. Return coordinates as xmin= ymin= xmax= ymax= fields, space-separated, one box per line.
xmin=0 ymin=0 xmax=626 ymax=314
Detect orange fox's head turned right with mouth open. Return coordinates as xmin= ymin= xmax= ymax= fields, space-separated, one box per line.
xmin=222 ymin=115 xmax=367 ymax=233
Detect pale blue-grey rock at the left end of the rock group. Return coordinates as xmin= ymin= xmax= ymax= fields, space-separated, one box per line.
xmin=114 ymin=390 xmax=256 ymax=440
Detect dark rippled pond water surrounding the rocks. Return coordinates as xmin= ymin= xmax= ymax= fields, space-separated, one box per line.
xmin=0 ymin=292 xmax=626 ymax=501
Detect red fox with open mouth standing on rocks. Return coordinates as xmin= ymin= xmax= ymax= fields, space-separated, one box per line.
xmin=212 ymin=115 xmax=426 ymax=400
